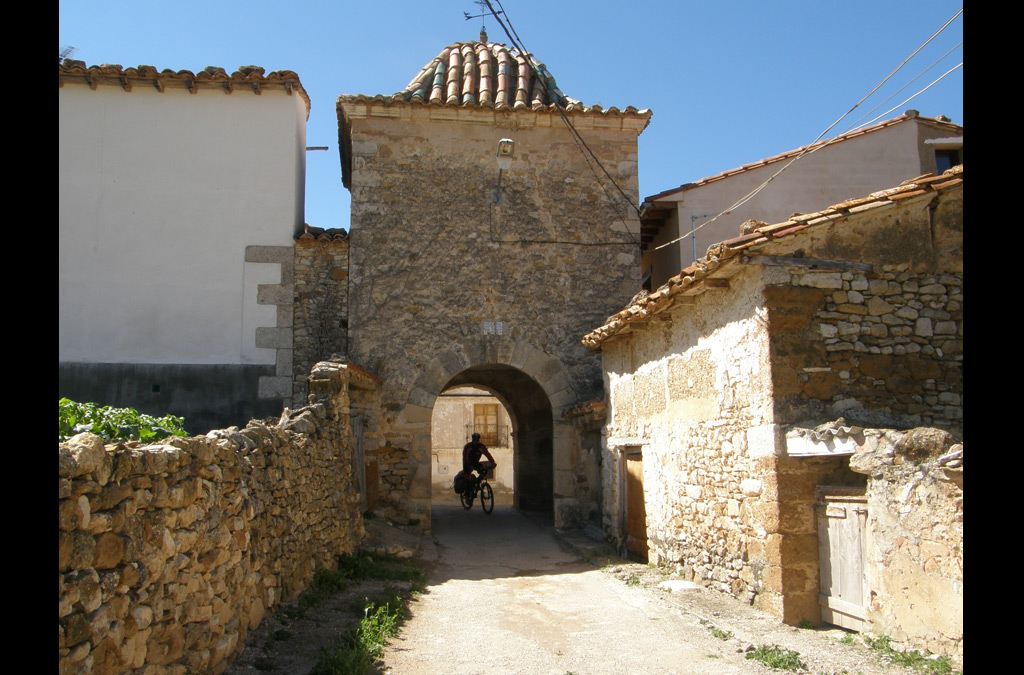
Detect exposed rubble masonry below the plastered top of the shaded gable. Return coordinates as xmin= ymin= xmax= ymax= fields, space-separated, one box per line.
xmin=765 ymin=265 xmax=964 ymax=433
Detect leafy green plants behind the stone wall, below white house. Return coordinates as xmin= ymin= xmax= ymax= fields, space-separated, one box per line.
xmin=57 ymin=398 xmax=187 ymax=442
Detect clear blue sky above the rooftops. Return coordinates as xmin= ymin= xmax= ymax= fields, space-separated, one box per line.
xmin=58 ymin=0 xmax=964 ymax=227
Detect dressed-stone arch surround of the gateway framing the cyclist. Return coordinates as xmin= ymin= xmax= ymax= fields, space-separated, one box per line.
xmin=396 ymin=335 xmax=577 ymax=524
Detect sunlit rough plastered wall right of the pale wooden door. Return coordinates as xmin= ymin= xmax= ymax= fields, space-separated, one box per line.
xmin=850 ymin=429 xmax=964 ymax=662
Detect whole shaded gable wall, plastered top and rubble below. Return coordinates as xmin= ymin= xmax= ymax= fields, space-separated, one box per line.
xmin=765 ymin=188 xmax=964 ymax=437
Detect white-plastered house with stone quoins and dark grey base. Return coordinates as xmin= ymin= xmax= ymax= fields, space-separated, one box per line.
xmin=57 ymin=60 xmax=312 ymax=431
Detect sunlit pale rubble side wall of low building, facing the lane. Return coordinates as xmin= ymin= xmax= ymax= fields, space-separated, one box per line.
xmin=602 ymin=268 xmax=782 ymax=614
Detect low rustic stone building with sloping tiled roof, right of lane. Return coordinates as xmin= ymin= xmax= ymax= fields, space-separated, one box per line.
xmin=583 ymin=166 xmax=964 ymax=655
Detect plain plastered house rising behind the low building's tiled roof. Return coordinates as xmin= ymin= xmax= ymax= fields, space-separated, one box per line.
xmin=641 ymin=111 xmax=964 ymax=291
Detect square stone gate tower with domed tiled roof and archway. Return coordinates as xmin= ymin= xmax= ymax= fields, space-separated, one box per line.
xmin=338 ymin=34 xmax=650 ymax=524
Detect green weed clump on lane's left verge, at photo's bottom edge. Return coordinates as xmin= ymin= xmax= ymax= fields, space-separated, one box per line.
xmin=312 ymin=595 xmax=406 ymax=675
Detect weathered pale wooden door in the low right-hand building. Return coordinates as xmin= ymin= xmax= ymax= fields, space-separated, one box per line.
xmin=817 ymin=489 xmax=867 ymax=631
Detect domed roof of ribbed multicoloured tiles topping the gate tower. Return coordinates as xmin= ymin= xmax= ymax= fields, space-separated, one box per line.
xmin=339 ymin=33 xmax=650 ymax=117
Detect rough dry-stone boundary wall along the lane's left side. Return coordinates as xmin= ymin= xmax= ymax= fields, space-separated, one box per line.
xmin=57 ymin=363 xmax=362 ymax=675
